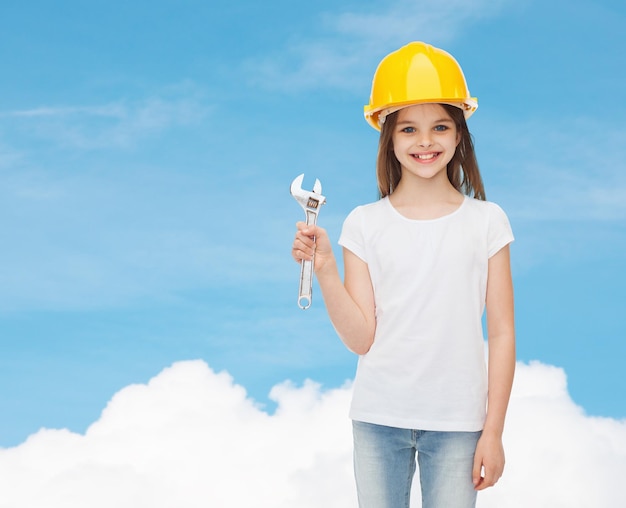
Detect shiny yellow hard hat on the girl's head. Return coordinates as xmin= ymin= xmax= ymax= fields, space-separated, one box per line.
xmin=363 ymin=42 xmax=478 ymax=130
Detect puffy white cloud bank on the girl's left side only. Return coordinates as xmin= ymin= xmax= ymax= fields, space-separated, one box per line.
xmin=0 ymin=362 xmax=351 ymax=508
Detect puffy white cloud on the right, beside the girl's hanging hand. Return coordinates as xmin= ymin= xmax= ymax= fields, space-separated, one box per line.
xmin=483 ymin=363 xmax=626 ymax=508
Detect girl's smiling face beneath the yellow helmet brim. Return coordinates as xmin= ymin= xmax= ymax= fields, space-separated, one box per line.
xmin=392 ymin=104 xmax=460 ymax=184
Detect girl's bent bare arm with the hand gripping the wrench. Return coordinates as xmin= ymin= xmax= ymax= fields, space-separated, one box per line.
xmin=292 ymin=222 xmax=376 ymax=355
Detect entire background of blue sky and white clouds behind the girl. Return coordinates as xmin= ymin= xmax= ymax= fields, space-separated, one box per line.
xmin=0 ymin=0 xmax=626 ymax=508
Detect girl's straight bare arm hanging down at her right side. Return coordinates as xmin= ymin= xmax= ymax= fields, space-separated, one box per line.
xmin=473 ymin=245 xmax=515 ymax=490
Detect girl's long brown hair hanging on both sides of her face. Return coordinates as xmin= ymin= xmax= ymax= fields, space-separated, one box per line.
xmin=376 ymin=104 xmax=486 ymax=201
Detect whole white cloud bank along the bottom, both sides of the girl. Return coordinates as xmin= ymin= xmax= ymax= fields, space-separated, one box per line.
xmin=0 ymin=361 xmax=626 ymax=508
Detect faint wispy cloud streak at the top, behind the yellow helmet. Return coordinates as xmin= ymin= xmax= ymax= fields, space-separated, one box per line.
xmin=244 ymin=0 xmax=512 ymax=92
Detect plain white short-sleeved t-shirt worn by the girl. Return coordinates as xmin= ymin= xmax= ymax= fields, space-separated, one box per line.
xmin=339 ymin=197 xmax=513 ymax=432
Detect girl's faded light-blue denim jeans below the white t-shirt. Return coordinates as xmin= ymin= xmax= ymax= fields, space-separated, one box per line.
xmin=352 ymin=421 xmax=481 ymax=508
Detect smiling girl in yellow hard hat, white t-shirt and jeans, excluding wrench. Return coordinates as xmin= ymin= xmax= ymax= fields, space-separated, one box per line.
xmin=292 ymin=42 xmax=515 ymax=508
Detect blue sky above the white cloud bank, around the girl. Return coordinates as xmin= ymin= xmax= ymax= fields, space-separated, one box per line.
xmin=0 ymin=0 xmax=626 ymax=447
